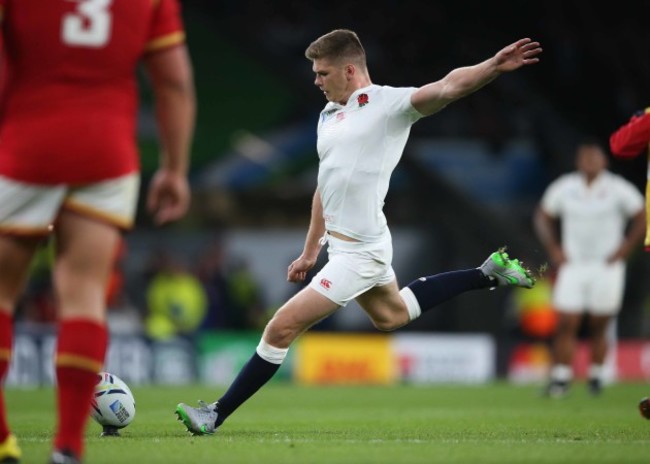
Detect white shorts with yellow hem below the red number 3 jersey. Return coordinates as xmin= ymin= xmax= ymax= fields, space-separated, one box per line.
xmin=0 ymin=173 xmax=140 ymax=235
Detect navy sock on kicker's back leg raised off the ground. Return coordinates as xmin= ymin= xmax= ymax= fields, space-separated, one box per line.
xmin=407 ymin=269 xmax=494 ymax=312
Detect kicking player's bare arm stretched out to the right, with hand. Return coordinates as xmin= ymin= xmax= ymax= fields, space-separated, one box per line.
xmin=411 ymin=38 xmax=542 ymax=116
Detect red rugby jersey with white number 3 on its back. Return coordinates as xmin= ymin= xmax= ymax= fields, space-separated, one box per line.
xmin=0 ymin=0 xmax=184 ymax=184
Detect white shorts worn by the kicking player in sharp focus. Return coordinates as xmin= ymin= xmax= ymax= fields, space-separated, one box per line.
xmin=309 ymin=233 xmax=395 ymax=306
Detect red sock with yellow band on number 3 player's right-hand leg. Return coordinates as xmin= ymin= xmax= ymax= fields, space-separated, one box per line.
xmin=54 ymin=319 xmax=108 ymax=457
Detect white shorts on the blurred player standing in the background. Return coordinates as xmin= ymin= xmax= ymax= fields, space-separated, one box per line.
xmin=553 ymin=261 xmax=625 ymax=316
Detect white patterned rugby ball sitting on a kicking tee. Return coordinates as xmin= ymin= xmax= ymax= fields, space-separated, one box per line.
xmin=90 ymin=372 xmax=135 ymax=429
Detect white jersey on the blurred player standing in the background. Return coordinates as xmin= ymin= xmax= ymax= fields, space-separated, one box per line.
xmin=541 ymin=171 xmax=644 ymax=261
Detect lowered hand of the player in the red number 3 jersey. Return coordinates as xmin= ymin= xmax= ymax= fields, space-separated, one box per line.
xmin=147 ymin=168 xmax=190 ymax=225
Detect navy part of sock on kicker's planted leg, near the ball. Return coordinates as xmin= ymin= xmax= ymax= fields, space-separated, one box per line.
xmin=216 ymin=352 xmax=280 ymax=427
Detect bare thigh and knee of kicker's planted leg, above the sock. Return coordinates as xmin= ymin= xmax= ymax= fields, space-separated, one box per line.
xmin=263 ymin=287 xmax=340 ymax=348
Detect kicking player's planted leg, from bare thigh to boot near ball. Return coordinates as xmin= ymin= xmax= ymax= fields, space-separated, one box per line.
xmin=176 ymin=287 xmax=339 ymax=435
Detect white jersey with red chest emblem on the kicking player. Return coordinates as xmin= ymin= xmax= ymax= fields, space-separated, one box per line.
xmin=317 ymin=85 xmax=423 ymax=242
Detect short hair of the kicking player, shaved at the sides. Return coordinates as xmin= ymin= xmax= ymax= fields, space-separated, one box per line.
xmin=305 ymin=29 xmax=366 ymax=68
